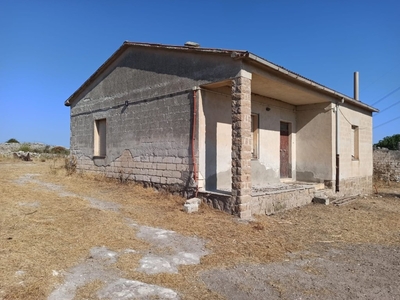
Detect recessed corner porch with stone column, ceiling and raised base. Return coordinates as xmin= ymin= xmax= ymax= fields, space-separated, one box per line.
xmin=198 ymin=70 xmax=333 ymax=218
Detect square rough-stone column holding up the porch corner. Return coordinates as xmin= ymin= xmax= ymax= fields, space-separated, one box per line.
xmin=232 ymin=71 xmax=251 ymax=219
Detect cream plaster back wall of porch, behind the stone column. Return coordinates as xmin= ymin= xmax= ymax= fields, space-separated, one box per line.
xmin=199 ymin=88 xmax=296 ymax=191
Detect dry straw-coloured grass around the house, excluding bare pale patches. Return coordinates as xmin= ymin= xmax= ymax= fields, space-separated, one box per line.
xmin=0 ymin=159 xmax=400 ymax=299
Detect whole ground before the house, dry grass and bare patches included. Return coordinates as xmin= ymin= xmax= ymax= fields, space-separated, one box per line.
xmin=0 ymin=158 xmax=400 ymax=300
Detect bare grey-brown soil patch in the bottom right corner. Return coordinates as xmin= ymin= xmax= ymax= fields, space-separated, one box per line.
xmin=201 ymin=245 xmax=400 ymax=300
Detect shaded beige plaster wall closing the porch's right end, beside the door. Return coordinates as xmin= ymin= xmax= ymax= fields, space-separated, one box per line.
xmin=296 ymin=103 xmax=335 ymax=182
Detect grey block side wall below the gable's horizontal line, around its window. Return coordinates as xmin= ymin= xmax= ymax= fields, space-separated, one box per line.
xmin=71 ymin=91 xmax=198 ymax=196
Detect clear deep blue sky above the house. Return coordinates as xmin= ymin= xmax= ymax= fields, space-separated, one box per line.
xmin=0 ymin=0 xmax=400 ymax=147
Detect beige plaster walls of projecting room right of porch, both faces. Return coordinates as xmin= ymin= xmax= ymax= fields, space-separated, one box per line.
xmin=297 ymin=103 xmax=372 ymax=197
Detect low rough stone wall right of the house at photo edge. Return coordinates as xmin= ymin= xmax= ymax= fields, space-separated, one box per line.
xmin=374 ymin=149 xmax=400 ymax=182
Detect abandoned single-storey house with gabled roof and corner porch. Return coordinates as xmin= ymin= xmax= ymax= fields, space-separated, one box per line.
xmin=65 ymin=42 xmax=376 ymax=218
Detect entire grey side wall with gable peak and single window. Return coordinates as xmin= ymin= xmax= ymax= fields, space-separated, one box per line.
xmin=71 ymin=48 xmax=240 ymax=196
